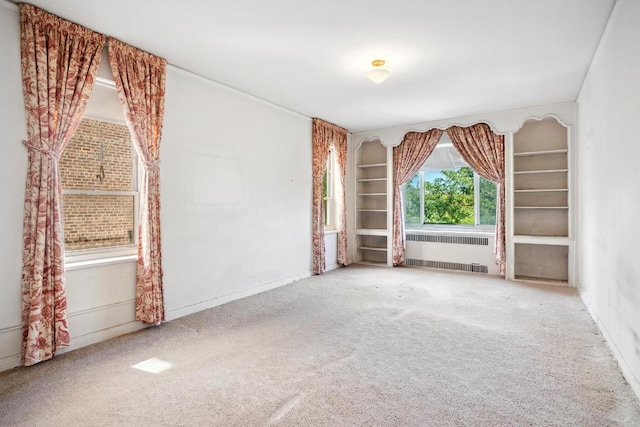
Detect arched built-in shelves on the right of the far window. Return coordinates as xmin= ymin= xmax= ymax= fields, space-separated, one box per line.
xmin=512 ymin=118 xmax=571 ymax=282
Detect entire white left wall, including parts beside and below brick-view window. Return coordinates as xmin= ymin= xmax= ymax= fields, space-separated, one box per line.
xmin=0 ymin=2 xmax=316 ymax=371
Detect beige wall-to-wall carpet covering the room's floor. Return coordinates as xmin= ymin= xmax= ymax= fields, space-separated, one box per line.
xmin=0 ymin=266 xmax=640 ymax=426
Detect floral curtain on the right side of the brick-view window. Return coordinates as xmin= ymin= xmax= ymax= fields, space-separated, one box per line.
xmin=109 ymin=38 xmax=166 ymax=325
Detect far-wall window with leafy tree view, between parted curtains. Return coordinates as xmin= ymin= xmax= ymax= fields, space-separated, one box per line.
xmin=403 ymin=139 xmax=497 ymax=226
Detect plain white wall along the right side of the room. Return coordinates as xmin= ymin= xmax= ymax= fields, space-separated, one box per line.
xmin=578 ymin=0 xmax=640 ymax=396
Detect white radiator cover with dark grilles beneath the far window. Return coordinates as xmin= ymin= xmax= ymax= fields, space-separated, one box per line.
xmin=404 ymin=234 xmax=495 ymax=274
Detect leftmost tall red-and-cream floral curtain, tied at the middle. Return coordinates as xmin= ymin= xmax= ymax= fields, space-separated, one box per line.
xmin=19 ymin=4 xmax=105 ymax=366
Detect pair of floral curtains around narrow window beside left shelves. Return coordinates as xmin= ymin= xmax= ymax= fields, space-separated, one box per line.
xmin=312 ymin=119 xmax=348 ymax=274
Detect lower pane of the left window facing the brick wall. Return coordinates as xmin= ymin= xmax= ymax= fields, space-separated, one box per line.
xmin=63 ymin=194 xmax=135 ymax=250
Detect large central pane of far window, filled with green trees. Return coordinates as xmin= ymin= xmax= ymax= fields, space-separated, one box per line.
xmin=424 ymin=167 xmax=474 ymax=224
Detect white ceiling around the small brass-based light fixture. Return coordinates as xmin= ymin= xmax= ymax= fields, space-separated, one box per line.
xmin=16 ymin=0 xmax=615 ymax=131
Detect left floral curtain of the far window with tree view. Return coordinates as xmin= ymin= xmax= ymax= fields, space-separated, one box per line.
xmin=393 ymin=129 xmax=443 ymax=265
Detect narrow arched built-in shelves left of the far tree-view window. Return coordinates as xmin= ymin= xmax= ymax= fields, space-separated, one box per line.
xmin=355 ymin=140 xmax=391 ymax=265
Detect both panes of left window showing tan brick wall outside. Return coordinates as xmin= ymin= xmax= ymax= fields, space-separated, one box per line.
xmin=59 ymin=113 xmax=138 ymax=256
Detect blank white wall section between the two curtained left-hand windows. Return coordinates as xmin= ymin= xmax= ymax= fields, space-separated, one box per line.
xmin=160 ymin=68 xmax=311 ymax=318
